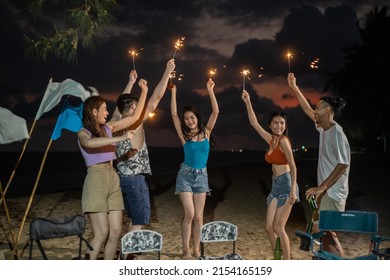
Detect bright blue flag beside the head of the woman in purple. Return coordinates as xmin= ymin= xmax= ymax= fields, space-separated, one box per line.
xmin=51 ymin=100 xmax=84 ymax=140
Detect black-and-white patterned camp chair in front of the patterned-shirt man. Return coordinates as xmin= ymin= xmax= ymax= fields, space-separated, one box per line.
xmin=119 ymin=230 xmax=163 ymax=260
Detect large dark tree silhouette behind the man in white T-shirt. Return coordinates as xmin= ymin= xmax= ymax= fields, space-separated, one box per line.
xmin=327 ymin=6 xmax=390 ymax=152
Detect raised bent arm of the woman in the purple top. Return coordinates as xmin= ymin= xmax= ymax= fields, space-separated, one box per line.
xmin=107 ymin=79 xmax=148 ymax=132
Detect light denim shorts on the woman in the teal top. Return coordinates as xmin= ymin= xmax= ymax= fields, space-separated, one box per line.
xmin=175 ymin=163 xmax=211 ymax=194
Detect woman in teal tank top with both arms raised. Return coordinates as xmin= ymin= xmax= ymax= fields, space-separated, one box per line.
xmin=171 ymin=79 xmax=219 ymax=259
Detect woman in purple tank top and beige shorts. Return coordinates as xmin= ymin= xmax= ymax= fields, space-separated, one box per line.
xmin=77 ymin=80 xmax=148 ymax=260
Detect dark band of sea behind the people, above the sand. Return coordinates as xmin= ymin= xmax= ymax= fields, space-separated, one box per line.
xmin=0 ymin=147 xmax=390 ymax=197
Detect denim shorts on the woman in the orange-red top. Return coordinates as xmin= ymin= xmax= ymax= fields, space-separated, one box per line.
xmin=267 ymin=172 xmax=299 ymax=207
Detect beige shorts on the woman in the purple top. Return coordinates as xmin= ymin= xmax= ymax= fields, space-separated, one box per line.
xmin=81 ymin=164 xmax=124 ymax=213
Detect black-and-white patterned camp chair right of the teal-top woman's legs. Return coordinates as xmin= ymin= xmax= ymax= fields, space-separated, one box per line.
xmin=199 ymin=221 xmax=242 ymax=260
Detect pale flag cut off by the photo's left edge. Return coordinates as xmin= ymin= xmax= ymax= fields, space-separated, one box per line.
xmin=0 ymin=107 xmax=30 ymax=144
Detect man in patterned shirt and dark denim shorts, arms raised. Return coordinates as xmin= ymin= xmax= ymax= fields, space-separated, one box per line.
xmin=114 ymin=59 xmax=175 ymax=231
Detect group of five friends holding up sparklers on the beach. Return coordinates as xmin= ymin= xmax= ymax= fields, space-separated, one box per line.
xmin=78 ymin=59 xmax=350 ymax=259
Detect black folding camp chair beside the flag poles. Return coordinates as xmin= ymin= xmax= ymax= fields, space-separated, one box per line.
xmin=29 ymin=215 xmax=93 ymax=260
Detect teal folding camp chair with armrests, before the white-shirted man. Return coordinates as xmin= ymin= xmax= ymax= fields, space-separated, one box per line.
xmin=295 ymin=211 xmax=390 ymax=260
